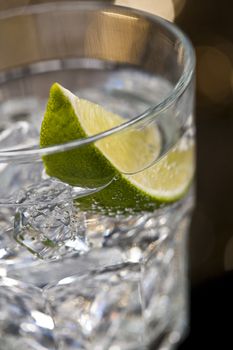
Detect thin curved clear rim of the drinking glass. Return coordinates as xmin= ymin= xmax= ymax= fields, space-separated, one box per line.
xmin=0 ymin=0 xmax=195 ymax=162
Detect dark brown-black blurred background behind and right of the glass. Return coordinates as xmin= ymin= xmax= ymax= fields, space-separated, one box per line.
xmin=0 ymin=0 xmax=233 ymax=350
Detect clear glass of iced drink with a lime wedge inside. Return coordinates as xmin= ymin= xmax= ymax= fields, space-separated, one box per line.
xmin=0 ymin=1 xmax=194 ymax=350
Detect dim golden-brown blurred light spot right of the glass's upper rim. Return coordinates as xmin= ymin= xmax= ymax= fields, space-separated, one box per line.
xmin=196 ymin=46 xmax=233 ymax=103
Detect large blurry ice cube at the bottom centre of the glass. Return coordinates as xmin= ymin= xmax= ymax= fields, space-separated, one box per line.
xmin=45 ymin=264 xmax=144 ymax=350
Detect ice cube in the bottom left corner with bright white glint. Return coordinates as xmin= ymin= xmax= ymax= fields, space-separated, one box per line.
xmin=0 ymin=277 xmax=57 ymax=350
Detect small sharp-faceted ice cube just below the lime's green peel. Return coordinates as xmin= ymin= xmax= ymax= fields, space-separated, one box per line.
xmin=14 ymin=179 xmax=88 ymax=260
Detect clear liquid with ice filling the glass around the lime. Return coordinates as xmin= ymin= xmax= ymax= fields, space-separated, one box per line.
xmin=0 ymin=64 xmax=193 ymax=350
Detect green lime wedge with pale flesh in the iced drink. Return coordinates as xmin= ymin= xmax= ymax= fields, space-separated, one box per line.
xmin=40 ymin=83 xmax=193 ymax=212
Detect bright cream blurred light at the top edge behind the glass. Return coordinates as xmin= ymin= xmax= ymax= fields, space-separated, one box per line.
xmin=115 ymin=0 xmax=175 ymax=21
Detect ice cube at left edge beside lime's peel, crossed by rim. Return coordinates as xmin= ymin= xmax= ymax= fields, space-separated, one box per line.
xmin=0 ymin=99 xmax=43 ymax=204
